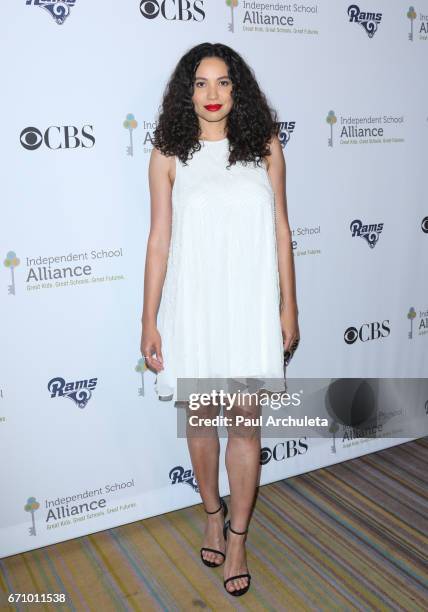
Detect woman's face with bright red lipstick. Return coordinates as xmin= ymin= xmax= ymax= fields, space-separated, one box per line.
xmin=192 ymin=57 xmax=233 ymax=128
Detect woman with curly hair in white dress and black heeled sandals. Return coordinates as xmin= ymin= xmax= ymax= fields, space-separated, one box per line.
xmin=141 ymin=43 xmax=299 ymax=596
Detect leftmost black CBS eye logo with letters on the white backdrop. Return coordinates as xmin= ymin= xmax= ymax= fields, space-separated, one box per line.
xmin=19 ymin=125 xmax=95 ymax=151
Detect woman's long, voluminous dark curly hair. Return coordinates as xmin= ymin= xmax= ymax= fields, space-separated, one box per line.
xmin=153 ymin=43 xmax=279 ymax=167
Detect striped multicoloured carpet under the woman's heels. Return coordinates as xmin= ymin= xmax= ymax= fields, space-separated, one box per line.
xmin=0 ymin=438 xmax=428 ymax=612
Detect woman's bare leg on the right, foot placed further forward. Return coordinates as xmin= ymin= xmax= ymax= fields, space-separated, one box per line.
xmin=224 ymin=394 xmax=260 ymax=591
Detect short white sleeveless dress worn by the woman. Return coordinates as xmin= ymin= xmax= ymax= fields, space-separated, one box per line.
xmin=155 ymin=138 xmax=285 ymax=400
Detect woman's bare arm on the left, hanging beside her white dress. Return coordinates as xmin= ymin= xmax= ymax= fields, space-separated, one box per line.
xmin=141 ymin=148 xmax=175 ymax=370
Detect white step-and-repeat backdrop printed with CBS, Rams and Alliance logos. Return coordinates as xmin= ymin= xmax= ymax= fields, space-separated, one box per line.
xmin=0 ymin=0 xmax=428 ymax=556
